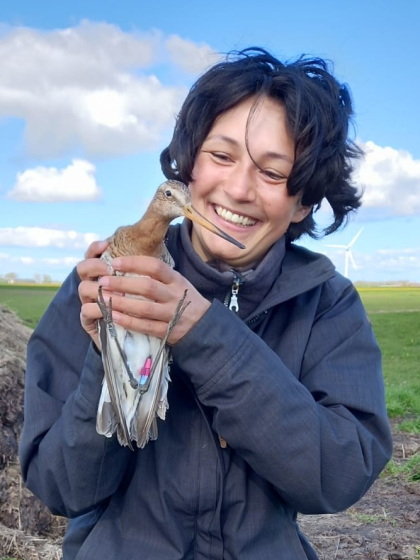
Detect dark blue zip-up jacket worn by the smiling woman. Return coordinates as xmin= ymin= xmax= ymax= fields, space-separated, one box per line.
xmin=20 ymin=226 xmax=392 ymax=560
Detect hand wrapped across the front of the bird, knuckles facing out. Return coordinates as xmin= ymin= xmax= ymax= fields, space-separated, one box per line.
xmin=97 ymin=256 xmax=210 ymax=344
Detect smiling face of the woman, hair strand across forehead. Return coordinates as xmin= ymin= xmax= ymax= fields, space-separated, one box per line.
xmin=189 ymin=98 xmax=311 ymax=268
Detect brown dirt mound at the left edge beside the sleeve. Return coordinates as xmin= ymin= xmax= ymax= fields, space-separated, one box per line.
xmin=0 ymin=307 xmax=65 ymax=560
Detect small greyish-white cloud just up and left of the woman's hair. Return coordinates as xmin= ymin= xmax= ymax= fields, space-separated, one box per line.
xmin=165 ymin=35 xmax=221 ymax=74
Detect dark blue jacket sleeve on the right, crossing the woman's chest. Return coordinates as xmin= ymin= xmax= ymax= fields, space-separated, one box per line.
xmin=173 ymin=280 xmax=392 ymax=514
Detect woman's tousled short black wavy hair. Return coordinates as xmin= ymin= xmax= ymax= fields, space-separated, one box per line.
xmin=160 ymin=47 xmax=363 ymax=241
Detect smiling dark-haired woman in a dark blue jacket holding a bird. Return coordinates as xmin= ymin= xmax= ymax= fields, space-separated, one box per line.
xmin=20 ymin=49 xmax=391 ymax=560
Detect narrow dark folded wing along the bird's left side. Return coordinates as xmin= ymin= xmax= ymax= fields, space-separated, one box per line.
xmin=99 ymin=320 xmax=133 ymax=450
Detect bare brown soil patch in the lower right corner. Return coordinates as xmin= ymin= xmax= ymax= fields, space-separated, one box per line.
xmin=299 ymin=423 xmax=420 ymax=560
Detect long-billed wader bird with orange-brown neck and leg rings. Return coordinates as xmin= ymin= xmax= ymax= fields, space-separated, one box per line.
xmin=96 ymin=181 xmax=244 ymax=449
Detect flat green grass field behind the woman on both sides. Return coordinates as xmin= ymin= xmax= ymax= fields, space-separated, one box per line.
xmin=0 ymin=285 xmax=420 ymax=432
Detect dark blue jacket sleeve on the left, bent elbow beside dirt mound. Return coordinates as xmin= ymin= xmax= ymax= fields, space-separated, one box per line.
xmin=19 ymin=270 xmax=129 ymax=517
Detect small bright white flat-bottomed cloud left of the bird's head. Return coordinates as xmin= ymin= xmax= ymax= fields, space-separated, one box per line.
xmin=7 ymin=160 xmax=101 ymax=202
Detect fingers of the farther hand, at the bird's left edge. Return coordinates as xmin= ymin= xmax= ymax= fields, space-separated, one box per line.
xmin=77 ymin=241 xmax=109 ymax=350
